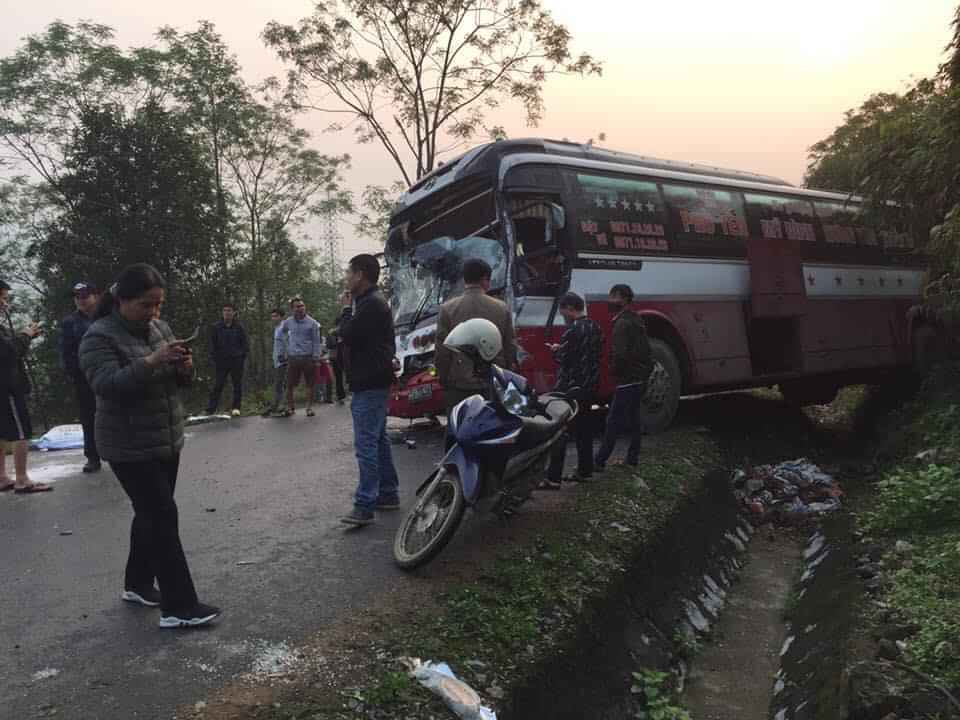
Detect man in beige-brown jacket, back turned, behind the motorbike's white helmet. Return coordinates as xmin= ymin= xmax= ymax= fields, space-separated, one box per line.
xmin=436 ymin=259 xmax=517 ymax=412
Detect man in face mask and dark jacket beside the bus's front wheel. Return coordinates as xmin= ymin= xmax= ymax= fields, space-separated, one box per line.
xmin=595 ymin=285 xmax=653 ymax=471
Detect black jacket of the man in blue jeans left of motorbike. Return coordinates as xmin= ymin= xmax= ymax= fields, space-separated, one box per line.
xmin=338 ymin=287 xmax=396 ymax=392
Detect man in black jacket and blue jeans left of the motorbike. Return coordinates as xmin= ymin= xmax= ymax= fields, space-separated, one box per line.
xmin=339 ymin=255 xmax=400 ymax=526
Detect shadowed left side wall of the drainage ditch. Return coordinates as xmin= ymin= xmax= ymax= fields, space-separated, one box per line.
xmin=500 ymin=472 xmax=753 ymax=720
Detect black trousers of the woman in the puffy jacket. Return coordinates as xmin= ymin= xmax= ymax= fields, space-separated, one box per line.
xmin=110 ymin=455 xmax=197 ymax=615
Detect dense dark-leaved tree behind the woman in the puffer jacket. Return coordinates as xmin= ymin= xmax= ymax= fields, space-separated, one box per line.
xmin=33 ymin=103 xmax=217 ymax=331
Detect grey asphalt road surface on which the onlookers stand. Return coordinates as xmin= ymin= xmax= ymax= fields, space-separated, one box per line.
xmin=0 ymin=406 xmax=442 ymax=720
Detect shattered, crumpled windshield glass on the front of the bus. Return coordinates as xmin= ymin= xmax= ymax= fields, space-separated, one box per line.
xmin=387 ymin=231 xmax=507 ymax=325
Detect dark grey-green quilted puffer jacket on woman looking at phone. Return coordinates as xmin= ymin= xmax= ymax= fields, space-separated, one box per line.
xmin=80 ymin=311 xmax=190 ymax=462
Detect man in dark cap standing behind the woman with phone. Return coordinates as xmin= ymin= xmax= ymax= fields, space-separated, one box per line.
xmin=60 ymin=282 xmax=100 ymax=473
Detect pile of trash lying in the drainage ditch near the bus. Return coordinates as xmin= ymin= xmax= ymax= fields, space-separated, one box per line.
xmin=733 ymin=458 xmax=843 ymax=524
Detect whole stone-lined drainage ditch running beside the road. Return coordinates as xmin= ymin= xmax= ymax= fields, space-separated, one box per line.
xmin=501 ymin=472 xmax=861 ymax=720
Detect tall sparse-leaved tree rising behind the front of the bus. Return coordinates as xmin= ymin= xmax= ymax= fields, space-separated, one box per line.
xmin=263 ymin=0 xmax=601 ymax=186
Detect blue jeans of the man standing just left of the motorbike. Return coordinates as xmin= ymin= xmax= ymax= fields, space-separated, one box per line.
xmin=350 ymin=388 xmax=400 ymax=510
